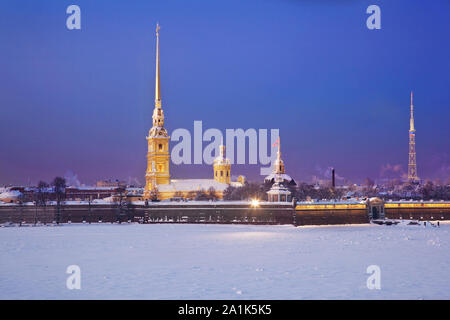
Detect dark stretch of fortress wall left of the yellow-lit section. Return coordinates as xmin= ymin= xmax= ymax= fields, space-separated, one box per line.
xmin=0 ymin=202 xmax=293 ymax=224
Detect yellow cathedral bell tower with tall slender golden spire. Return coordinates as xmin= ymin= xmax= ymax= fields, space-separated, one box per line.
xmin=144 ymin=24 xmax=170 ymax=199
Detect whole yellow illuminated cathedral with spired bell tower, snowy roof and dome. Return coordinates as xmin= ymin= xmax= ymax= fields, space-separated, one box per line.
xmin=144 ymin=25 xmax=244 ymax=200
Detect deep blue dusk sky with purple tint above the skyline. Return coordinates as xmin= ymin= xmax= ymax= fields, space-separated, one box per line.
xmin=0 ymin=0 xmax=450 ymax=185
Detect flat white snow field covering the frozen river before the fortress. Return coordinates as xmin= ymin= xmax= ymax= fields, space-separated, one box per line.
xmin=0 ymin=224 xmax=450 ymax=299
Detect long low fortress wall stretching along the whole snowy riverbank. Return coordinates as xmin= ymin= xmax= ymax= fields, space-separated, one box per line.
xmin=0 ymin=201 xmax=450 ymax=225
